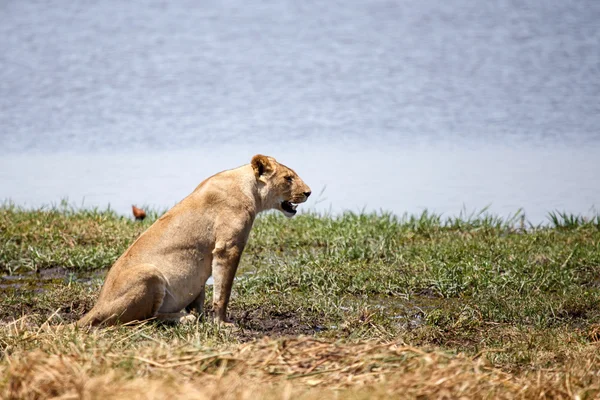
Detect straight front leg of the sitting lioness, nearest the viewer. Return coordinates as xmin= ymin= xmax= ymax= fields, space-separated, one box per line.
xmin=212 ymin=243 xmax=243 ymax=322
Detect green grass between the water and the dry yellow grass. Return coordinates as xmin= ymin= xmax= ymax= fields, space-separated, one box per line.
xmin=0 ymin=204 xmax=600 ymax=368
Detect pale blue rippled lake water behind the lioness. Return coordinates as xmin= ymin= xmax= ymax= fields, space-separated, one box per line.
xmin=0 ymin=0 xmax=600 ymax=223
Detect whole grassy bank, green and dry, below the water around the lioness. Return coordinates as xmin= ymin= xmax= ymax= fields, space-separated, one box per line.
xmin=0 ymin=206 xmax=600 ymax=398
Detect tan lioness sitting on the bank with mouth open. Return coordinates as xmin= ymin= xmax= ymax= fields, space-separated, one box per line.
xmin=77 ymin=155 xmax=311 ymax=326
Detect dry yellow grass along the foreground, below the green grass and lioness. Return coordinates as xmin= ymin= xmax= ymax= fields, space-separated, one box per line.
xmin=0 ymin=324 xmax=600 ymax=399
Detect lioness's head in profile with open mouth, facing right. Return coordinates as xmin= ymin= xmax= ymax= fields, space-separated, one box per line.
xmin=251 ymin=154 xmax=311 ymax=218
